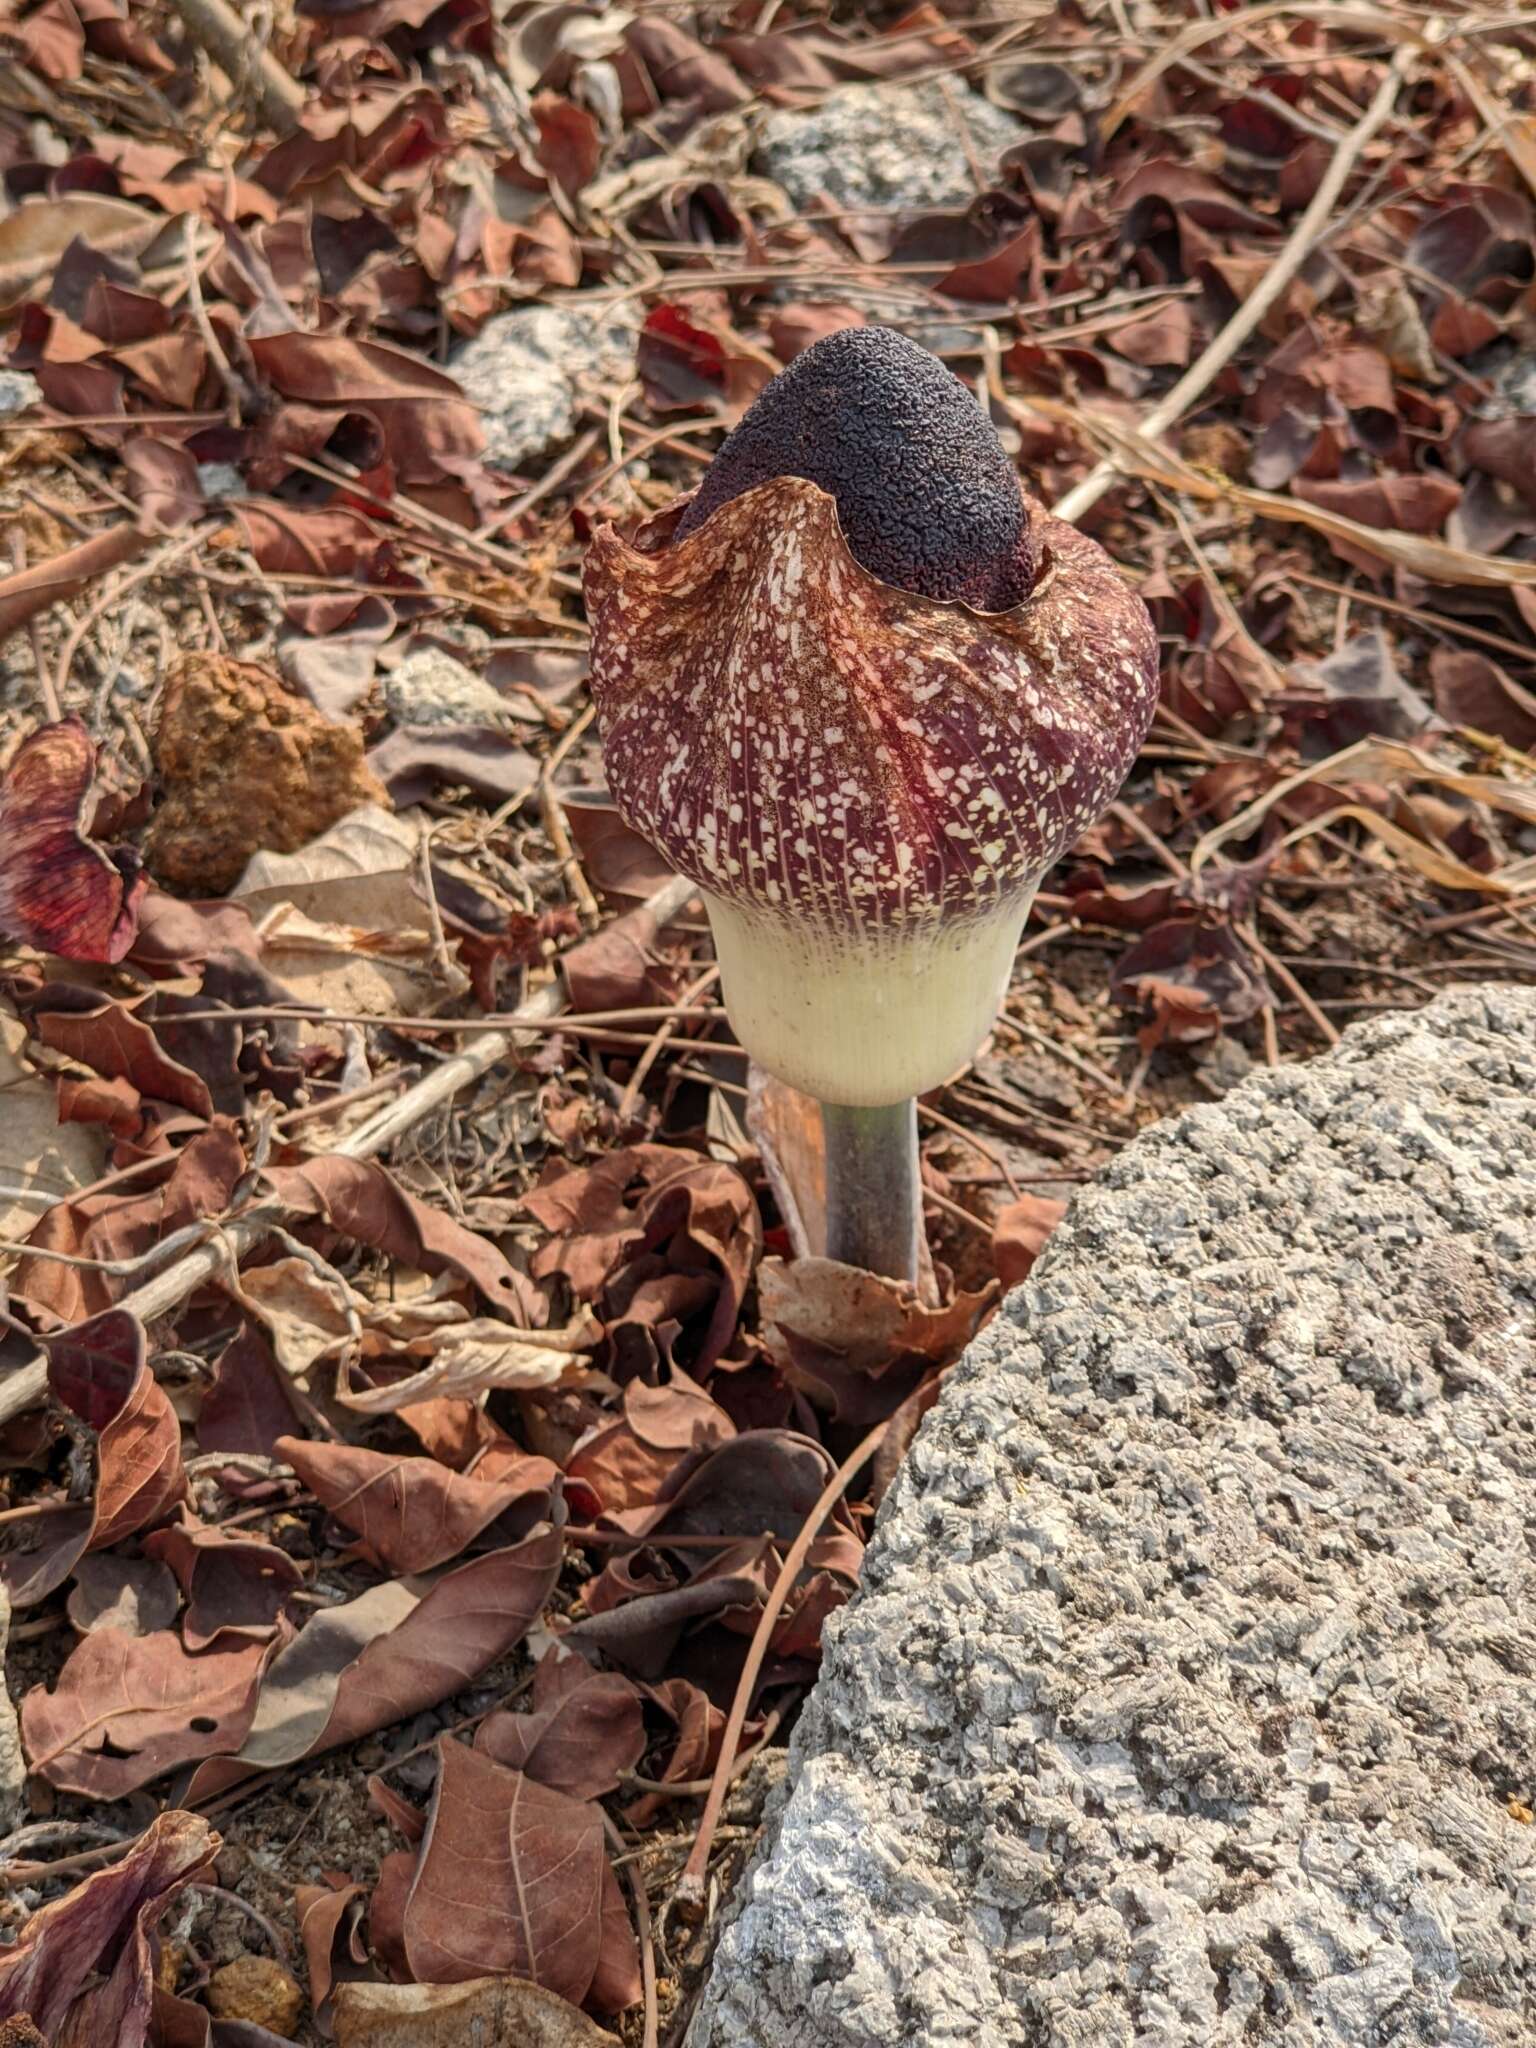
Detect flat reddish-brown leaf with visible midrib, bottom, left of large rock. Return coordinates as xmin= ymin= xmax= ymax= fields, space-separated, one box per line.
xmin=406 ymin=1737 xmax=639 ymax=2011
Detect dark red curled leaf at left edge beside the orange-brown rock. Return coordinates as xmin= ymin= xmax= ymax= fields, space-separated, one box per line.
xmin=0 ymin=719 xmax=147 ymax=961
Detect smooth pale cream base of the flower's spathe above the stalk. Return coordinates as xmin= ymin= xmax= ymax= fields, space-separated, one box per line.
xmin=705 ymin=887 xmax=1034 ymax=1108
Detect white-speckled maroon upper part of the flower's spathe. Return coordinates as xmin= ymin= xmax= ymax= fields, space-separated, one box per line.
xmin=586 ymin=477 xmax=1157 ymax=938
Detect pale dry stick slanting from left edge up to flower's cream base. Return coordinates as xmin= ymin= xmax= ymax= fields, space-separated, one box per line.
xmin=0 ymin=879 xmax=698 ymax=1423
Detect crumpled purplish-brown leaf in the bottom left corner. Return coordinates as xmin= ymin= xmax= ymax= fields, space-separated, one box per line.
xmin=0 ymin=1812 xmax=219 ymax=2048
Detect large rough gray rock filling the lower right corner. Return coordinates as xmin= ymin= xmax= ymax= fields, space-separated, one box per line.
xmin=688 ymin=987 xmax=1536 ymax=2048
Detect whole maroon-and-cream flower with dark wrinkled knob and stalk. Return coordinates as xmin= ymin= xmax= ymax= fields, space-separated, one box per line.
xmin=586 ymin=328 xmax=1157 ymax=1276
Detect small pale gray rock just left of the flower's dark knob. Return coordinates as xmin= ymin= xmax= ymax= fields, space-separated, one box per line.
xmin=453 ymin=301 xmax=639 ymax=469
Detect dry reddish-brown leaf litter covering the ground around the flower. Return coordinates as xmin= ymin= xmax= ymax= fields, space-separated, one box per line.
xmin=0 ymin=0 xmax=1536 ymax=2048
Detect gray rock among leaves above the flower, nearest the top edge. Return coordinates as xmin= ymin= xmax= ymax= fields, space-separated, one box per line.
xmin=754 ymin=78 xmax=1028 ymax=213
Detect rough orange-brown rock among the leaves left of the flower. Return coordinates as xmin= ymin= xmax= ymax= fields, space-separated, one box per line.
xmin=143 ymin=651 xmax=389 ymax=897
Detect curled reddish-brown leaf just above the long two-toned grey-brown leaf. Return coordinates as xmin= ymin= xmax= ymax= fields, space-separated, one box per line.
xmin=276 ymin=1436 xmax=549 ymax=1571
